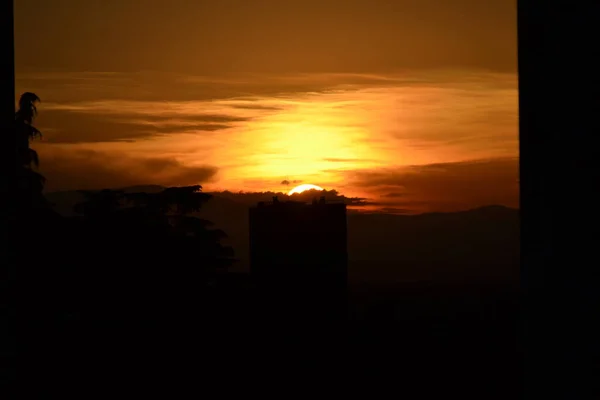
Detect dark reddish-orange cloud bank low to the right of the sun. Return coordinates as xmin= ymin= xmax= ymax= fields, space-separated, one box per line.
xmin=345 ymin=158 xmax=519 ymax=212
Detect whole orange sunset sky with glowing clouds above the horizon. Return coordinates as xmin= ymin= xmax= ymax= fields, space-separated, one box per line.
xmin=15 ymin=0 xmax=518 ymax=212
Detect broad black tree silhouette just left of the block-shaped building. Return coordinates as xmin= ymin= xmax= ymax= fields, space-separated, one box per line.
xmin=72 ymin=185 xmax=233 ymax=316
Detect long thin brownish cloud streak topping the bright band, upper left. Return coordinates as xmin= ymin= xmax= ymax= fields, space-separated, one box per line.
xmin=16 ymin=71 xmax=427 ymax=105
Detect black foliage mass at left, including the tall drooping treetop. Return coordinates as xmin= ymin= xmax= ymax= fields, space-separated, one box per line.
xmin=15 ymin=92 xmax=234 ymax=328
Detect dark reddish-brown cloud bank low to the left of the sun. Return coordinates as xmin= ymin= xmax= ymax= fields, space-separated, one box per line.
xmin=38 ymin=147 xmax=217 ymax=191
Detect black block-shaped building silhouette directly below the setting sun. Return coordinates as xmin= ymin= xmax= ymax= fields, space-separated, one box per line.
xmin=250 ymin=198 xmax=348 ymax=320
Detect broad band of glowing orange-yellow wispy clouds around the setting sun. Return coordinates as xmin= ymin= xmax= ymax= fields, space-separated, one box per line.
xmin=23 ymin=70 xmax=518 ymax=210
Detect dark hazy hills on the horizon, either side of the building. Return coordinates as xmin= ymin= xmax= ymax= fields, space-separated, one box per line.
xmin=46 ymin=185 xmax=519 ymax=286
